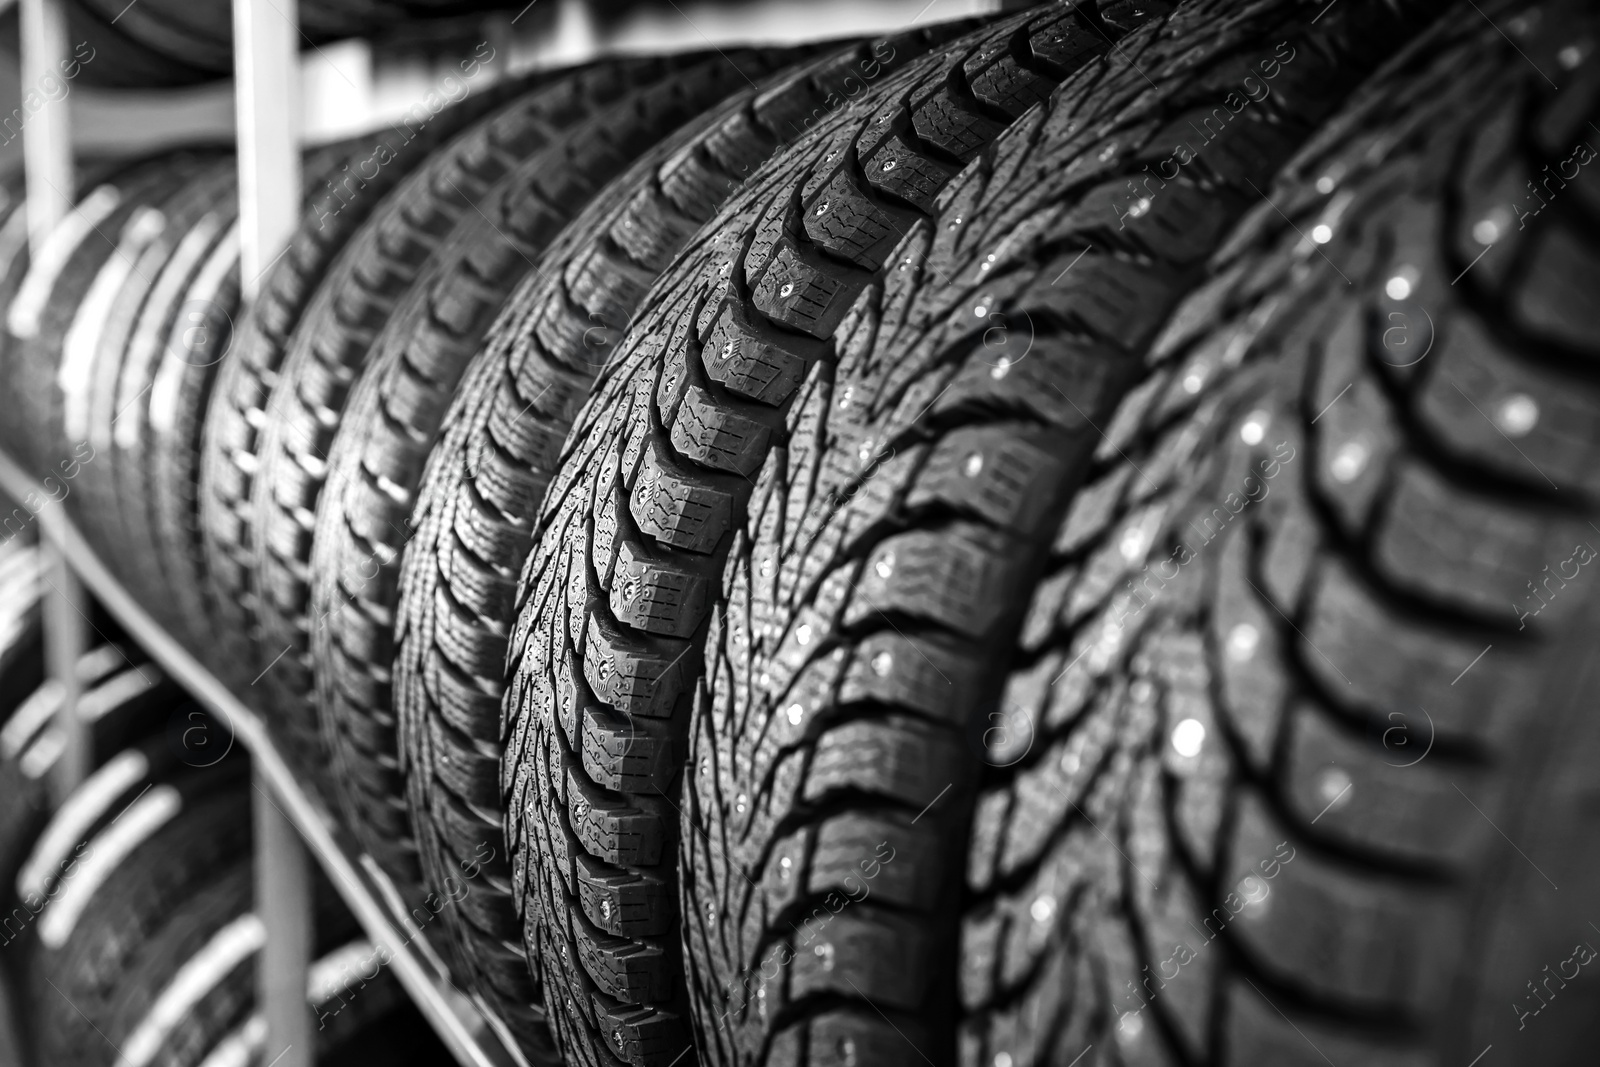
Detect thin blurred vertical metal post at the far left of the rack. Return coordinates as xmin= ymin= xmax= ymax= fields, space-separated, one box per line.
xmin=19 ymin=0 xmax=90 ymax=801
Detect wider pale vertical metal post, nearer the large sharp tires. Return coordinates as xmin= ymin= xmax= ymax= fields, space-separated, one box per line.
xmin=234 ymin=0 xmax=315 ymax=1067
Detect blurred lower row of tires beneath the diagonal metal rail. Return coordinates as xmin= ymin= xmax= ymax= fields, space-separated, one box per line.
xmin=0 ymin=598 xmax=446 ymax=1067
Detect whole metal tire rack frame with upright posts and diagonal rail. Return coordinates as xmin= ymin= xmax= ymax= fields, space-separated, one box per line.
xmin=0 ymin=0 xmax=525 ymax=1067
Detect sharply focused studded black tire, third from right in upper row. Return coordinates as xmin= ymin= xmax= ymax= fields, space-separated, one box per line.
xmin=492 ymin=4 xmax=1203 ymax=1064
